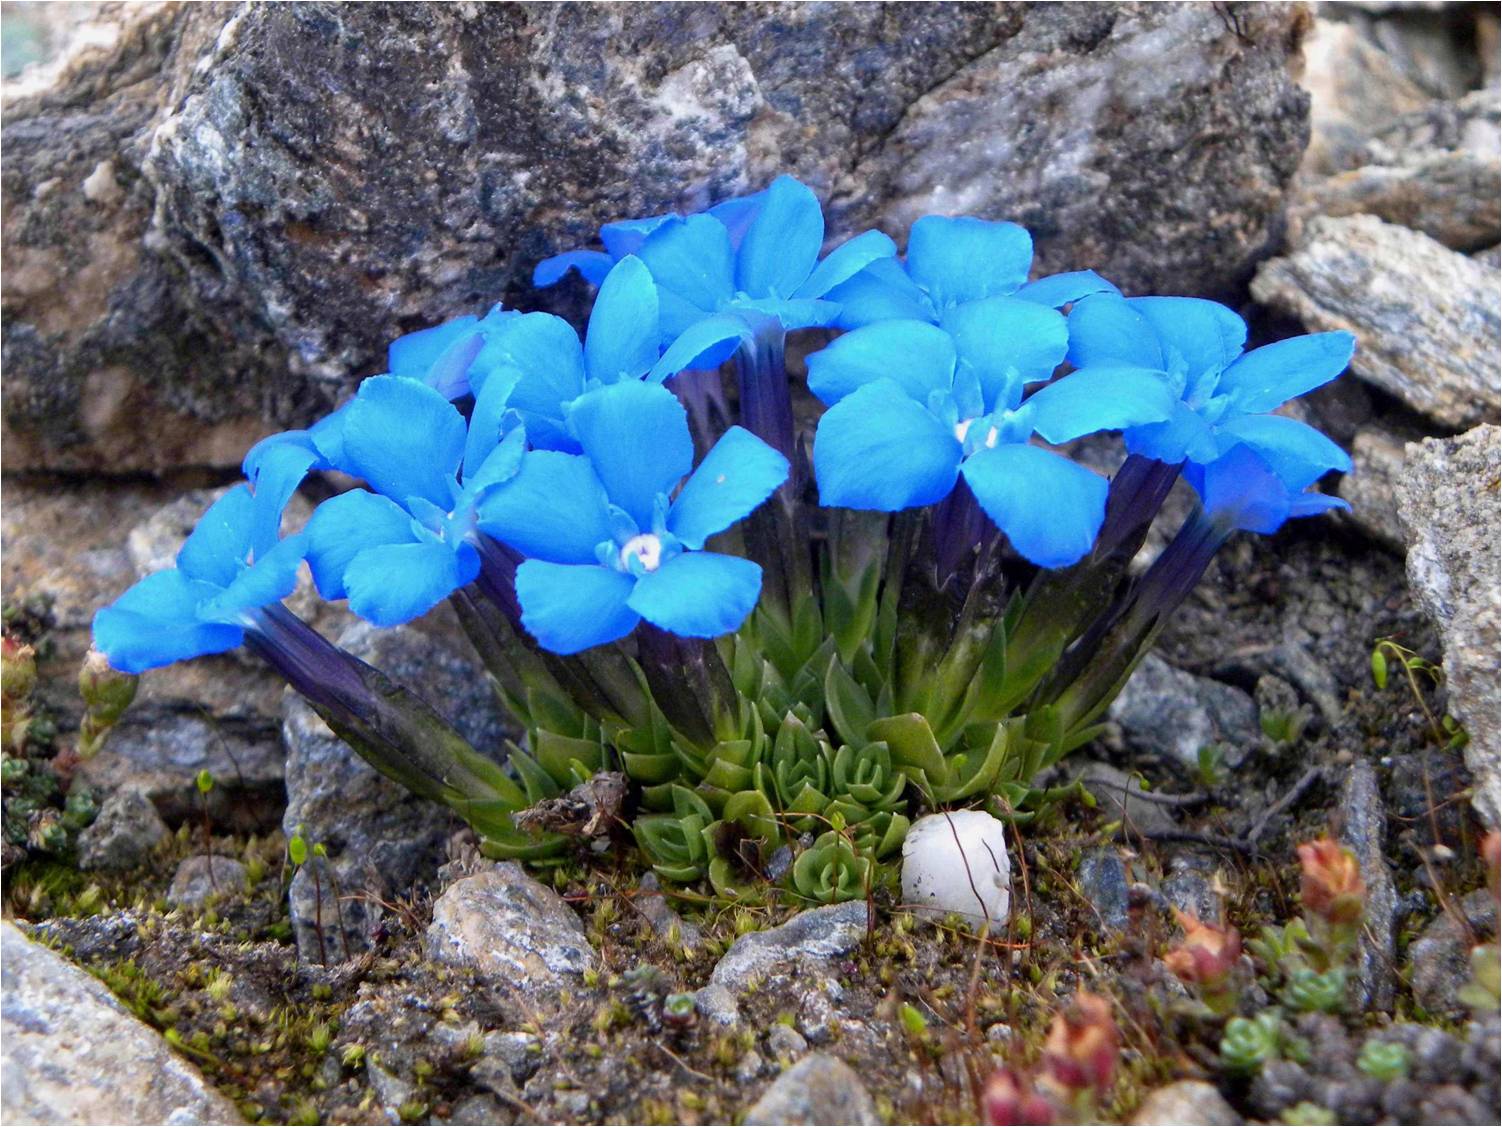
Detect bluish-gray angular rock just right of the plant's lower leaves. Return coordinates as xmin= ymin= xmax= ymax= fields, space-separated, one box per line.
xmin=1107 ymin=654 xmax=1262 ymax=771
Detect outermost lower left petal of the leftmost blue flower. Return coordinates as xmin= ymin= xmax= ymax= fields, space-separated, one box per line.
xmin=93 ymin=570 xmax=245 ymax=673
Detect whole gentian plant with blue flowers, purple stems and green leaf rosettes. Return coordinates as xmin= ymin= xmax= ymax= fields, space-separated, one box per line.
xmin=95 ymin=177 xmax=1353 ymax=902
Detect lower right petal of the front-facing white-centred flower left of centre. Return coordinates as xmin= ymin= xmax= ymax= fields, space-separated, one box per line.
xmin=629 ymin=551 xmax=762 ymax=637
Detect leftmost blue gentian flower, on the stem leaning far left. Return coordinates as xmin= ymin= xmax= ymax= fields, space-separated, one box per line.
xmin=93 ymin=485 xmax=305 ymax=673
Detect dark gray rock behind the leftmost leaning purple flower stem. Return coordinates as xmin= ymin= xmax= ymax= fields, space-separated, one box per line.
xmin=282 ymin=622 xmax=509 ymax=962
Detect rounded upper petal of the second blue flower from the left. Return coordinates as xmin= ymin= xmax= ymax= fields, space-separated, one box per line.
xmin=342 ymin=376 xmax=466 ymax=511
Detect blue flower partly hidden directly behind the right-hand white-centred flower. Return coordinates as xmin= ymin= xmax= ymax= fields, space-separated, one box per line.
xmin=829 ymin=215 xmax=1116 ymax=329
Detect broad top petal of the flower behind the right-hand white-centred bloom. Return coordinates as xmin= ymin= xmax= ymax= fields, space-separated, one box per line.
xmin=907 ymin=215 xmax=1032 ymax=307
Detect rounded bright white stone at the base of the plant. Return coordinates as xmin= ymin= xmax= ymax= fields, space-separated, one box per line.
xmin=903 ymin=810 xmax=1012 ymax=929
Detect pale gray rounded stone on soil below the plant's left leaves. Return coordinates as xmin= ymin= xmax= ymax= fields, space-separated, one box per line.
xmin=428 ymin=861 xmax=596 ymax=1005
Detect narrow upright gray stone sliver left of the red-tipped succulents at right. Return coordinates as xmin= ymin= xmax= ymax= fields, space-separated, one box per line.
xmin=1340 ymin=759 xmax=1398 ymax=1010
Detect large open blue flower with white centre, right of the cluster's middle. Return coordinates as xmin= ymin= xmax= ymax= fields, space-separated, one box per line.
xmin=808 ymin=314 xmax=1173 ymax=568
